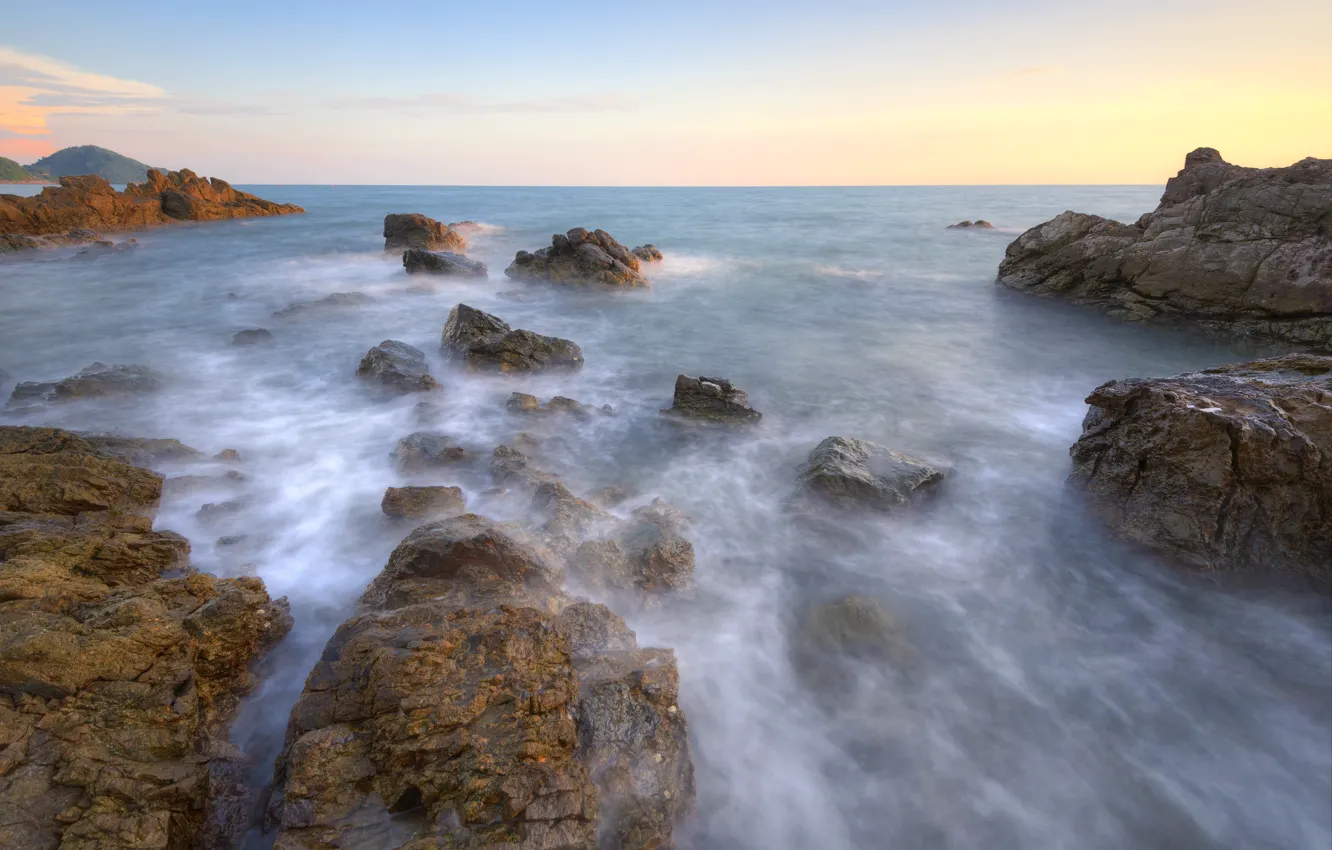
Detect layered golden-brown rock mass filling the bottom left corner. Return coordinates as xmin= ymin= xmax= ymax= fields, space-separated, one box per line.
xmin=0 ymin=428 xmax=290 ymax=849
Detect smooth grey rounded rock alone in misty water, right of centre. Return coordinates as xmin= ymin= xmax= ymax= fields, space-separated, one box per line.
xmin=799 ymin=437 xmax=948 ymax=512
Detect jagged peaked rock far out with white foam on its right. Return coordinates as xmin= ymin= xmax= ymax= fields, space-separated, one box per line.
xmin=503 ymin=228 xmax=650 ymax=288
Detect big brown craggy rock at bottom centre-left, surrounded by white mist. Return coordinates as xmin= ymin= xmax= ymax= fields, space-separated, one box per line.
xmin=263 ymin=514 xmax=694 ymax=850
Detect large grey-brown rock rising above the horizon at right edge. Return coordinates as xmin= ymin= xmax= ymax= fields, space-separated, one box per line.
xmin=999 ymin=148 xmax=1332 ymax=349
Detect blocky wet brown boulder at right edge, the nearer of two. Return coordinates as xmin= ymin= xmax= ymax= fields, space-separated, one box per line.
xmin=1070 ymin=354 xmax=1332 ymax=592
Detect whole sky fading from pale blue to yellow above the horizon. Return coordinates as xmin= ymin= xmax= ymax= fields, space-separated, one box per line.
xmin=0 ymin=0 xmax=1332 ymax=185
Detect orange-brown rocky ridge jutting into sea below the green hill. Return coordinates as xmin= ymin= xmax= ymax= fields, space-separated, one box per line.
xmin=0 ymin=169 xmax=305 ymax=250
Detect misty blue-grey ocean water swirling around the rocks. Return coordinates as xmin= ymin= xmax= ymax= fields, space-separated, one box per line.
xmin=0 ymin=187 xmax=1332 ymax=850
